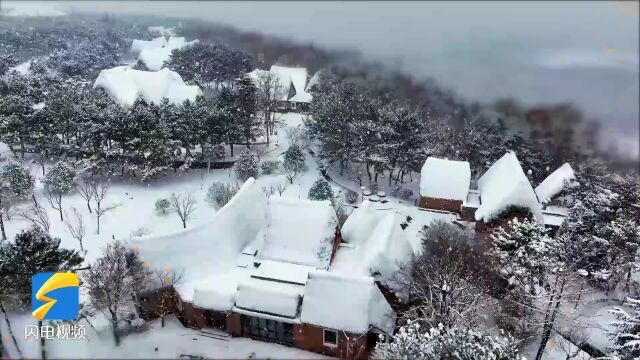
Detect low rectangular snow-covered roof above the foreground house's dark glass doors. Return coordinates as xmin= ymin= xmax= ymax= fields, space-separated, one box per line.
xmin=236 ymin=278 xmax=304 ymax=319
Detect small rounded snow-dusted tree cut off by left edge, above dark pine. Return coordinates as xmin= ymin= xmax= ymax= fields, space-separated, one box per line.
xmin=0 ymin=162 xmax=34 ymax=240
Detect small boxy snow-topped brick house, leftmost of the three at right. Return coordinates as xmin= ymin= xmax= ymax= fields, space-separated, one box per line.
xmin=420 ymin=157 xmax=471 ymax=213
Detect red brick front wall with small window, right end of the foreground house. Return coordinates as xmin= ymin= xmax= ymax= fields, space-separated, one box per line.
xmin=293 ymin=324 xmax=369 ymax=359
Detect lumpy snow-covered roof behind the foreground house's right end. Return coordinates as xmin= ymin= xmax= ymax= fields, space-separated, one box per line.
xmin=330 ymin=201 xmax=414 ymax=280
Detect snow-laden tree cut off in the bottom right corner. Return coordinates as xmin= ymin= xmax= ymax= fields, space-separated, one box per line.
xmin=609 ymin=298 xmax=640 ymax=359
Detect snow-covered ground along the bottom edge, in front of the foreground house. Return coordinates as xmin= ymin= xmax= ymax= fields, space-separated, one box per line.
xmin=0 ymin=313 xmax=326 ymax=359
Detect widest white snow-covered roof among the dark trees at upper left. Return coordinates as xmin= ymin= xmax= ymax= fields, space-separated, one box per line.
xmin=93 ymin=66 xmax=202 ymax=106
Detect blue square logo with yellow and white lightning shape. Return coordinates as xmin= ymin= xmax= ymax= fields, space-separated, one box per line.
xmin=31 ymin=272 xmax=80 ymax=320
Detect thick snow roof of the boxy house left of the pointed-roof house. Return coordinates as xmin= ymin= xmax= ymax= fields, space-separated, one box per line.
xmin=420 ymin=157 xmax=471 ymax=201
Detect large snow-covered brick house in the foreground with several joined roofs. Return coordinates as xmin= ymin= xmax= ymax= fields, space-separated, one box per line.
xmin=136 ymin=179 xmax=395 ymax=358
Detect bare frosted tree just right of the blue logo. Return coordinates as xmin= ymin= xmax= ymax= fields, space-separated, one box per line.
xmin=82 ymin=242 xmax=151 ymax=346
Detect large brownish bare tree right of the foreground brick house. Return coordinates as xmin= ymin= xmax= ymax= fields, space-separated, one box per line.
xmin=394 ymin=222 xmax=495 ymax=328
